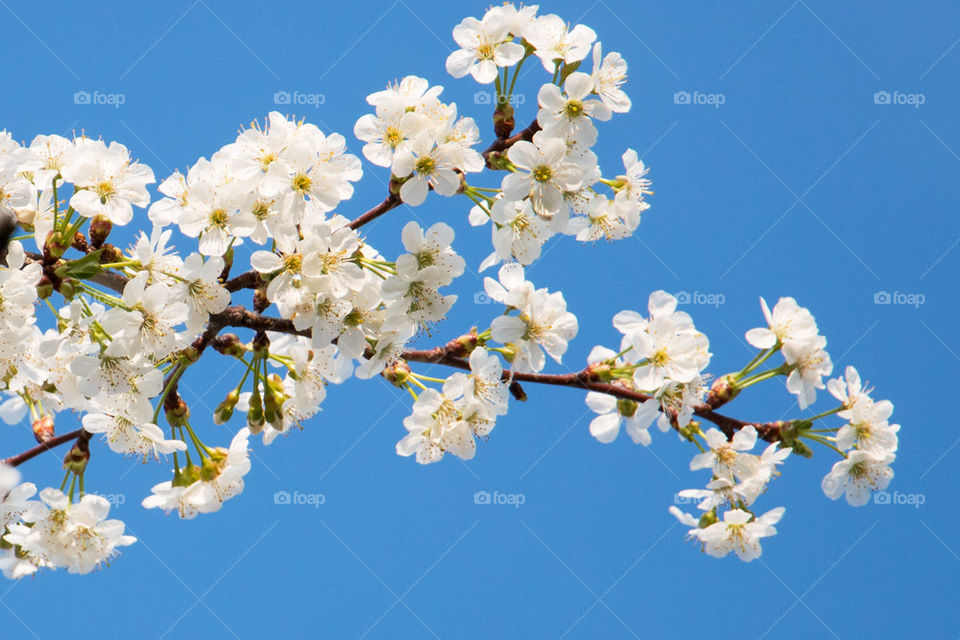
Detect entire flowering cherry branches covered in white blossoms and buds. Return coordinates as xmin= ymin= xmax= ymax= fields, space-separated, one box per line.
xmin=0 ymin=3 xmax=900 ymax=578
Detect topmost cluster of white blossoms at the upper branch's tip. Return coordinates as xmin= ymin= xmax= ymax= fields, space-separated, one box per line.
xmin=447 ymin=4 xmax=652 ymax=270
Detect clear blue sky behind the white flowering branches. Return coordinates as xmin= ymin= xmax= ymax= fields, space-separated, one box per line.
xmin=0 ymin=0 xmax=960 ymax=638
